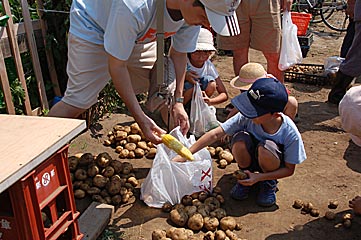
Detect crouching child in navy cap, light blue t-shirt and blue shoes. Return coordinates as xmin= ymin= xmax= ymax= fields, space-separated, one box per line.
xmin=174 ymin=78 xmax=306 ymax=207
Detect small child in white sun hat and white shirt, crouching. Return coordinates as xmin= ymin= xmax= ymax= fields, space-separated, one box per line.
xmin=183 ymin=28 xmax=228 ymax=106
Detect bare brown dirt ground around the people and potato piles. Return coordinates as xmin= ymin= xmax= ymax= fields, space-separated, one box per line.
xmin=69 ymin=25 xmax=361 ymax=240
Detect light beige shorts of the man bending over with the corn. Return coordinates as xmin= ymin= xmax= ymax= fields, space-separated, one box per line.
xmin=62 ymin=34 xmax=156 ymax=109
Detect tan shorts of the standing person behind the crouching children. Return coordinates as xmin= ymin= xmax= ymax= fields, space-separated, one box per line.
xmin=217 ymin=0 xmax=281 ymax=53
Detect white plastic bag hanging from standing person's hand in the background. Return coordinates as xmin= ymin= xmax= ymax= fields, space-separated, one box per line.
xmin=278 ymin=10 xmax=303 ymax=71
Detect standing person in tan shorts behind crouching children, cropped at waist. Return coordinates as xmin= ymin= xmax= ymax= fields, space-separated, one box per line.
xmin=217 ymin=0 xmax=292 ymax=82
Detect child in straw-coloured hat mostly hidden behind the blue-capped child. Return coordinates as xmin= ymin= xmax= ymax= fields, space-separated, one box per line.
xmin=227 ymin=63 xmax=298 ymax=120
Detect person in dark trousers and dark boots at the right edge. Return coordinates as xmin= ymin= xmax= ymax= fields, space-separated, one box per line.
xmin=328 ymin=0 xmax=361 ymax=104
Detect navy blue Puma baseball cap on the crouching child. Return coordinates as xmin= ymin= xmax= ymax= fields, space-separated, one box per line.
xmin=231 ymin=78 xmax=288 ymax=119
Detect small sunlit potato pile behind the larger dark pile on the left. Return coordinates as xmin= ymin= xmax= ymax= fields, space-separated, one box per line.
xmin=104 ymin=123 xmax=157 ymax=159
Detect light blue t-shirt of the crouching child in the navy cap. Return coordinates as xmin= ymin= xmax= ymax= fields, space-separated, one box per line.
xmin=221 ymin=113 xmax=307 ymax=164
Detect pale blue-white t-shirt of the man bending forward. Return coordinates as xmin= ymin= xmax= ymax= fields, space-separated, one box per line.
xmin=69 ymin=0 xmax=200 ymax=60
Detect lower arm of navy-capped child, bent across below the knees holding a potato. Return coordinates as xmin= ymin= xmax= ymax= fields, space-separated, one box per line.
xmin=238 ymin=162 xmax=296 ymax=186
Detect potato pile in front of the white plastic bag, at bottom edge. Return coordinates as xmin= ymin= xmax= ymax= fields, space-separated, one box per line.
xmin=152 ymin=187 xmax=241 ymax=240
